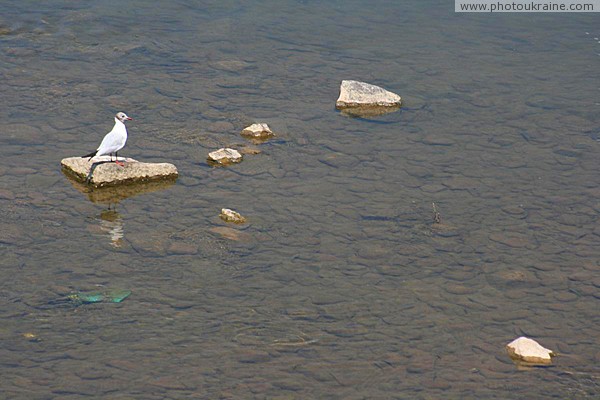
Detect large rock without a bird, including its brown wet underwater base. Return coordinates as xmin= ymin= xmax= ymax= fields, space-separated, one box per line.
xmin=335 ymin=81 xmax=402 ymax=116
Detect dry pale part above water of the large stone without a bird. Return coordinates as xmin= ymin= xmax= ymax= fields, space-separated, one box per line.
xmin=335 ymin=81 xmax=402 ymax=109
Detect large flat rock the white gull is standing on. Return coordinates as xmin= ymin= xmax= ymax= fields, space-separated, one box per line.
xmin=60 ymin=156 xmax=178 ymax=187
